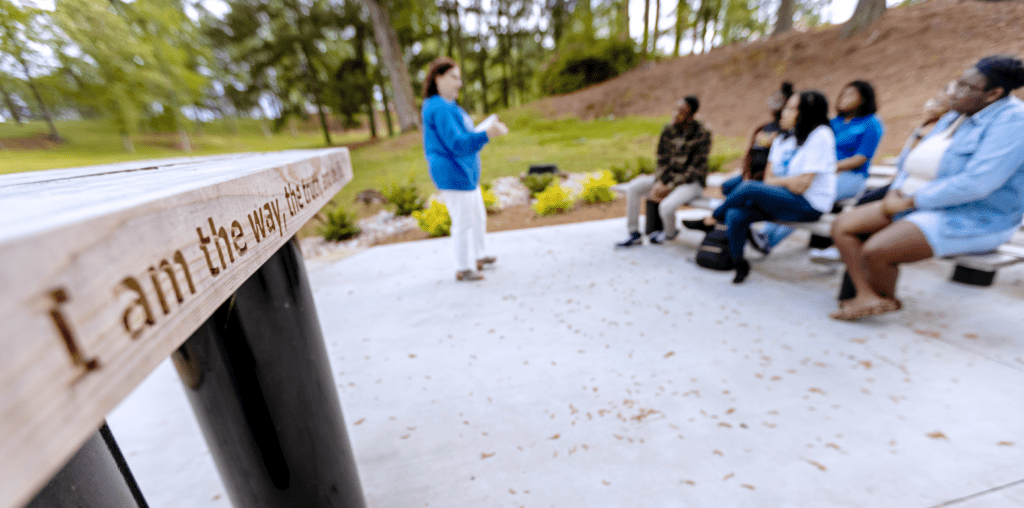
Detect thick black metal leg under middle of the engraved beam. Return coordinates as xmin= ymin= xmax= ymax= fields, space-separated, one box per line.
xmin=173 ymin=241 xmax=365 ymax=508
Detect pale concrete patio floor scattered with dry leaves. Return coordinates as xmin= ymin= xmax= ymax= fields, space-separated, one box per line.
xmin=109 ymin=214 xmax=1024 ymax=508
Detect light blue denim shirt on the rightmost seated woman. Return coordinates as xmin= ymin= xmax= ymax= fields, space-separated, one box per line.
xmin=893 ymin=95 xmax=1024 ymax=238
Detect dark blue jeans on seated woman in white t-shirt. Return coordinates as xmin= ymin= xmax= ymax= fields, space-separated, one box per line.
xmin=712 ymin=180 xmax=821 ymax=261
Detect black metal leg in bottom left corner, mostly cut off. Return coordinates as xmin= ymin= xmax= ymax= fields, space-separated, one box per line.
xmin=26 ymin=423 xmax=147 ymax=508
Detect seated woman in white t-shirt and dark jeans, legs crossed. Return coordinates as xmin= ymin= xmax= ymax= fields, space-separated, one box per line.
xmin=683 ymin=91 xmax=836 ymax=284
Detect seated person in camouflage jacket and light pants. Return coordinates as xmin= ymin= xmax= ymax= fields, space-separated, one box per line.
xmin=615 ymin=95 xmax=711 ymax=247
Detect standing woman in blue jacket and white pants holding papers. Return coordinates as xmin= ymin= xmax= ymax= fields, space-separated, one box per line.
xmin=423 ymin=56 xmax=508 ymax=281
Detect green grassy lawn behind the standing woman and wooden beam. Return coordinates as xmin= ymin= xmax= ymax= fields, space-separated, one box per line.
xmin=0 ymin=108 xmax=746 ymax=236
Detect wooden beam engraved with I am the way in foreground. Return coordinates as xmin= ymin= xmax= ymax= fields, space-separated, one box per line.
xmin=0 ymin=149 xmax=352 ymax=507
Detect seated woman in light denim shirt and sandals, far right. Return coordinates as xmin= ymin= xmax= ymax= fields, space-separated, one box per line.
xmin=830 ymin=56 xmax=1024 ymax=321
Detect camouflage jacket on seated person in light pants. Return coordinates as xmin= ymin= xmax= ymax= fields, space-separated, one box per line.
xmin=654 ymin=120 xmax=711 ymax=187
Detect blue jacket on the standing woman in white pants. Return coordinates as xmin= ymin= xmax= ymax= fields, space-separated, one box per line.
xmin=423 ymin=95 xmax=488 ymax=191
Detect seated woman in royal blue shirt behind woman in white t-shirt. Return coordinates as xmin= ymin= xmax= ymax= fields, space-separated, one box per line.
xmin=754 ymin=80 xmax=885 ymax=254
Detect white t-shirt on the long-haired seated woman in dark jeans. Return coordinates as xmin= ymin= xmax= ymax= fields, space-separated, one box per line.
xmin=768 ymin=125 xmax=838 ymax=213
